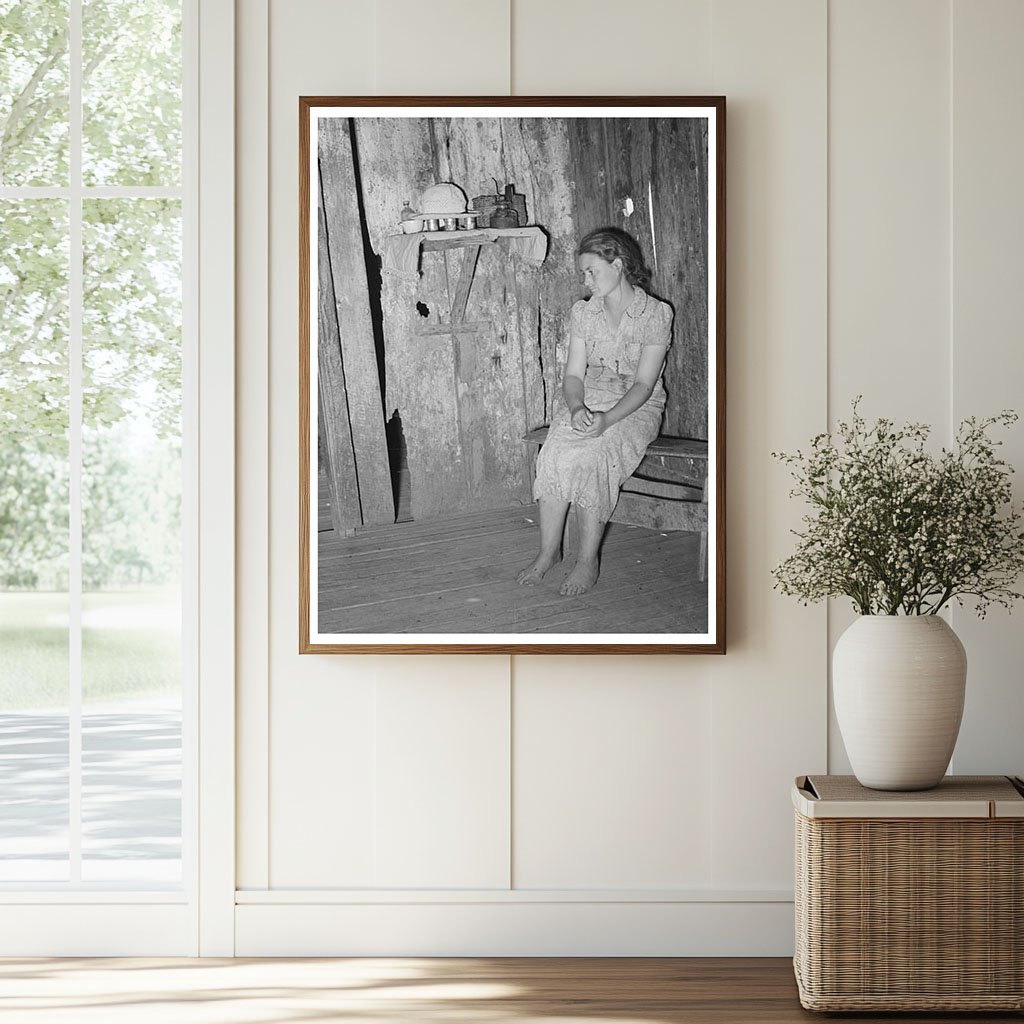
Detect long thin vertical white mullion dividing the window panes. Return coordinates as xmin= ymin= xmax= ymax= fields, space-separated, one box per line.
xmin=68 ymin=0 xmax=84 ymax=885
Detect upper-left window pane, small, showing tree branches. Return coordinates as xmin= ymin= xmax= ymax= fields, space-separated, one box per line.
xmin=0 ymin=0 xmax=69 ymax=185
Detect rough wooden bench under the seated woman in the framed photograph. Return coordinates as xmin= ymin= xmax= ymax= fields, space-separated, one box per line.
xmin=523 ymin=427 xmax=708 ymax=582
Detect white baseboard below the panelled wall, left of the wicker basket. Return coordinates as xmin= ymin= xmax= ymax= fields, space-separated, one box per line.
xmin=234 ymin=893 xmax=794 ymax=956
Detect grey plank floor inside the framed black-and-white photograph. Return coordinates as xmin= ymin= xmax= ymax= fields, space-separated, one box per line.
xmin=318 ymin=505 xmax=708 ymax=633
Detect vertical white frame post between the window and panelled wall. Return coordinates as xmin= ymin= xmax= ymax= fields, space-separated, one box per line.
xmin=198 ymin=0 xmax=236 ymax=956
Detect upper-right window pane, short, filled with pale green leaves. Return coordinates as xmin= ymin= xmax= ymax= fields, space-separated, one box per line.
xmin=82 ymin=0 xmax=181 ymax=185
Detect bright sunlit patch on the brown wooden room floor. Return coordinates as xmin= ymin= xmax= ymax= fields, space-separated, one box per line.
xmin=0 ymin=957 xmax=679 ymax=1024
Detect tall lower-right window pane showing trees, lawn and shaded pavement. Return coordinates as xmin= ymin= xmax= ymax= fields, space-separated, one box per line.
xmin=82 ymin=199 xmax=181 ymax=884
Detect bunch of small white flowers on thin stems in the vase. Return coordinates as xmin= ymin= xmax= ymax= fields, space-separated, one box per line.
xmin=772 ymin=397 xmax=1024 ymax=617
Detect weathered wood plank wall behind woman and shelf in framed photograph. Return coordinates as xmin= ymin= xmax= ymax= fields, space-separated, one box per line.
xmin=315 ymin=118 xmax=708 ymax=519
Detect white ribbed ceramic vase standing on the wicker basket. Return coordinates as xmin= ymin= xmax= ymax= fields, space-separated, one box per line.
xmin=833 ymin=615 xmax=967 ymax=790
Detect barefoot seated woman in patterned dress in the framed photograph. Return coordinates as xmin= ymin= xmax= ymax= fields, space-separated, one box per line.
xmin=517 ymin=227 xmax=672 ymax=595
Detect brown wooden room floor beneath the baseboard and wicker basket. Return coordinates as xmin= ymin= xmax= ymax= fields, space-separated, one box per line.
xmin=0 ymin=958 xmax=1024 ymax=1024
